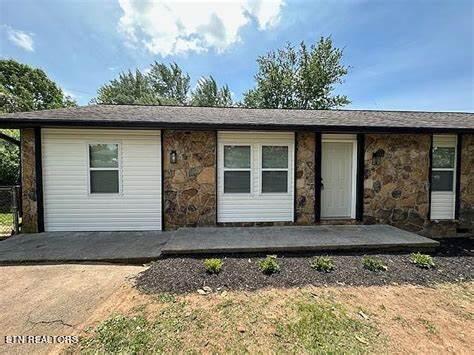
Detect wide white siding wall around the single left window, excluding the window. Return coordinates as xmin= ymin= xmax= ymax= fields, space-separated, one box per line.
xmin=42 ymin=128 xmax=161 ymax=231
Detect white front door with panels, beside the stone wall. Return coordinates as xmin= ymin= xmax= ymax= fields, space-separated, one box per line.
xmin=321 ymin=141 xmax=354 ymax=218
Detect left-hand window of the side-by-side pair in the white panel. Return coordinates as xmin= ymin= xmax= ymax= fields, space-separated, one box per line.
xmin=223 ymin=145 xmax=252 ymax=194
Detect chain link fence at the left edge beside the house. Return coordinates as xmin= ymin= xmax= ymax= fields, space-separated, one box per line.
xmin=0 ymin=186 xmax=20 ymax=239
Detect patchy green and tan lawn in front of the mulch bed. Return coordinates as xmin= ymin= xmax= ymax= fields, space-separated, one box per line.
xmin=65 ymin=282 xmax=474 ymax=355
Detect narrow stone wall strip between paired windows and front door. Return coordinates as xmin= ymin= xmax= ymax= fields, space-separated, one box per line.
xmin=295 ymin=132 xmax=316 ymax=225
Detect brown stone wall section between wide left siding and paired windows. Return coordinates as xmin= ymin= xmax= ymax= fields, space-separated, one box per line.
xmin=162 ymin=130 xmax=217 ymax=229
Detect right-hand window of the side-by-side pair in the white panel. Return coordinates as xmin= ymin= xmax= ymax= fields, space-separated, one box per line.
xmin=260 ymin=145 xmax=290 ymax=194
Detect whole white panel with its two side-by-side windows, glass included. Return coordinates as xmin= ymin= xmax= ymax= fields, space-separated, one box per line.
xmin=217 ymin=131 xmax=295 ymax=223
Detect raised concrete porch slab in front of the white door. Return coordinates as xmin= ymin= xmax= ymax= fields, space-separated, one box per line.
xmin=161 ymin=225 xmax=439 ymax=255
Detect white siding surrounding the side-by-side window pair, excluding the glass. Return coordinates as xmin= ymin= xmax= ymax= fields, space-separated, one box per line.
xmin=217 ymin=132 xmax=294 ymax=222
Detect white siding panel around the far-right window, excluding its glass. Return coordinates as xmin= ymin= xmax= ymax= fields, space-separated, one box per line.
xmin=430 ymin=134 xmax=457 ymax=220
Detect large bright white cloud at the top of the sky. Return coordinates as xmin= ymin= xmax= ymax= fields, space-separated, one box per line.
xmin=118 ymin=0 xmax=284 ymax=56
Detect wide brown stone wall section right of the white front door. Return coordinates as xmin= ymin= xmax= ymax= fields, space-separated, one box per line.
xmin=364 ymin=134 xmax=431 ymax=232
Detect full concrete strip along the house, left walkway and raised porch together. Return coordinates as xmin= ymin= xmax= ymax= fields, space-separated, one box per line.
xmin=0 ymin=225 xmax=439 ymax=264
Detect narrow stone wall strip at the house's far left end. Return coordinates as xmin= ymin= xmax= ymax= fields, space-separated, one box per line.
xmin=21 ymin=128 xmax=38 ymax=233
